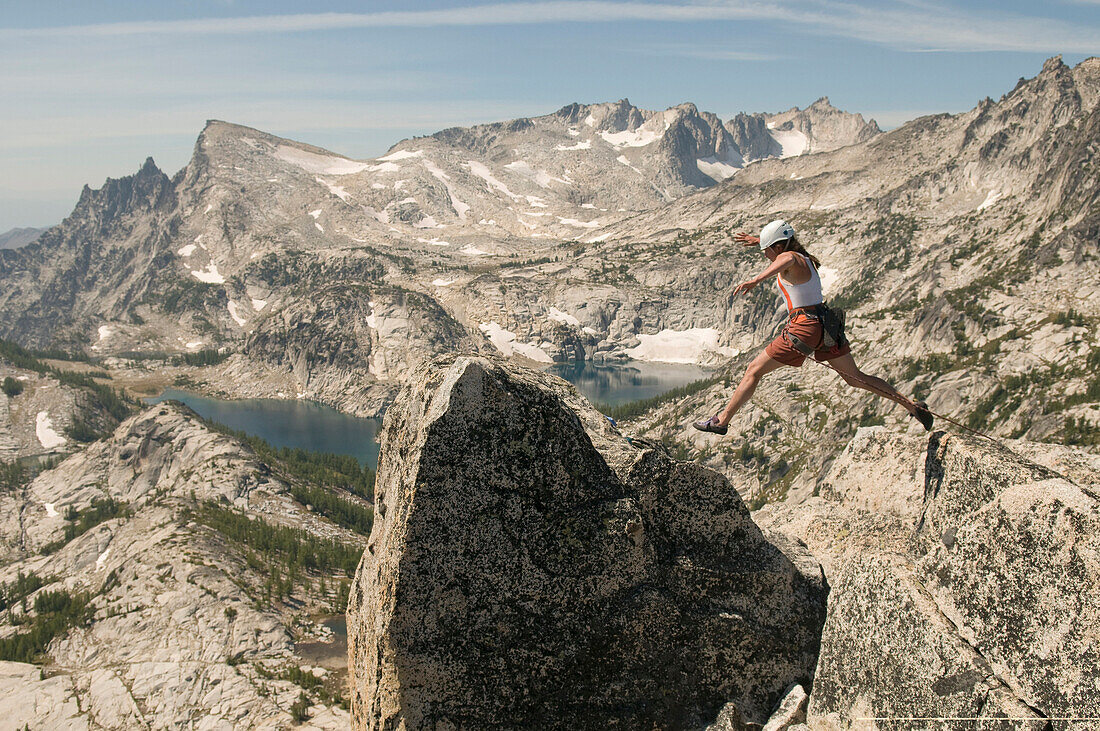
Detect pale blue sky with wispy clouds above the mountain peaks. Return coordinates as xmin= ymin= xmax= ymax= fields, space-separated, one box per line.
xmin=0 ymin=0 xmax=1100 ymax=232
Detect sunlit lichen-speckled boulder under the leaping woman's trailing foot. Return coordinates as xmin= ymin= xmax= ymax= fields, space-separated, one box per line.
xmin=756 ymin=428 xmax=1100 ymax=729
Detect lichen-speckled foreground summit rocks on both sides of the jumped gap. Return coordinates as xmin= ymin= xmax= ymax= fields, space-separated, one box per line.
xmin=349 ymin=356 xmax=1100 ymax=731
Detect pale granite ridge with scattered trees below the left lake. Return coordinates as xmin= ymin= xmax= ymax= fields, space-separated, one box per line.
xmin=0 ymin=403 xmax=363 ymax=730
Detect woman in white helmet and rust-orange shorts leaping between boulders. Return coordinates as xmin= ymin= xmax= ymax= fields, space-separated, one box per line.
xmin=695 ymin=221 xmax=932 ymax=434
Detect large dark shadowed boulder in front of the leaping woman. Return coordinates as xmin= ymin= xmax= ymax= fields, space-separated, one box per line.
xmin=349 ymin=356 xmax=827 ymax=729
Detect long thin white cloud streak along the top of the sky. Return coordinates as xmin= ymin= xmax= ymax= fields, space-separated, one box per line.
xmin=0 ymin=0 xmax=1100 ymax=53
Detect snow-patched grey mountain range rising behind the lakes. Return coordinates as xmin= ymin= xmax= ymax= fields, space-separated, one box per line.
xmin=0 ymin=58 xmax=1100 ymax=446
